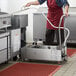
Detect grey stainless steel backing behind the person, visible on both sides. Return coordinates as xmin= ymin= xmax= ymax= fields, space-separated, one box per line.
xmin=33 ymin=13 xmax=76 ymax=43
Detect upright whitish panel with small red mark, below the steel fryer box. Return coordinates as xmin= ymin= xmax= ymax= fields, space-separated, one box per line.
xmin=10 ymin=28 xmax=21 ymax=57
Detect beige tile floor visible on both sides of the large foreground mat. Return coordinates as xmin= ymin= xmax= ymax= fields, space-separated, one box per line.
xmin=0 ymin=49 xmax=76 ymax=76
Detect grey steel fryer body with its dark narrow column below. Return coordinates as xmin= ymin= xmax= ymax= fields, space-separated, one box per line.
xmin=11 ymin=14 xmax=28 ymax=47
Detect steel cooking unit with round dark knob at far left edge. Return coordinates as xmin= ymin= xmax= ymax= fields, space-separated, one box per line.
xmin=0 ymin=12 xmax=11 ymax=63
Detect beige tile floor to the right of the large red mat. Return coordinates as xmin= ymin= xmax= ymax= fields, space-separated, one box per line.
xmin=53 ymin=55 xmax=76 ymax=76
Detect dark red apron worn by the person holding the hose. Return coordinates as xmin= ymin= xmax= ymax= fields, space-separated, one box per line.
xmin=47 ymin=0 xmax=64 ymax=30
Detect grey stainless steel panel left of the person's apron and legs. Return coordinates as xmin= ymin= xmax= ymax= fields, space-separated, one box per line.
xmin=33 ymin=13 xmax=47 ymax=41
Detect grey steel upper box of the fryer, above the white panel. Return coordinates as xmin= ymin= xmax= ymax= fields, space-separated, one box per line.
xmin=11 ymin=14 xmax=28 ymax=28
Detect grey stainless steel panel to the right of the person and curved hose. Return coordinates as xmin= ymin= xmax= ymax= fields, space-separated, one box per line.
xmin=65 ymin=15 xmax=76 ymax=43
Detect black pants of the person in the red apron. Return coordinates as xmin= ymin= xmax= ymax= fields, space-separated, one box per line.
xmin=45 ymin=29 xmax=64 ymax=45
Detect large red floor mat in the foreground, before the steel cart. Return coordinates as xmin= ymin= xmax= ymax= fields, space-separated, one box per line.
xmin=0 ymin=63 xmax=61 ymax=76
